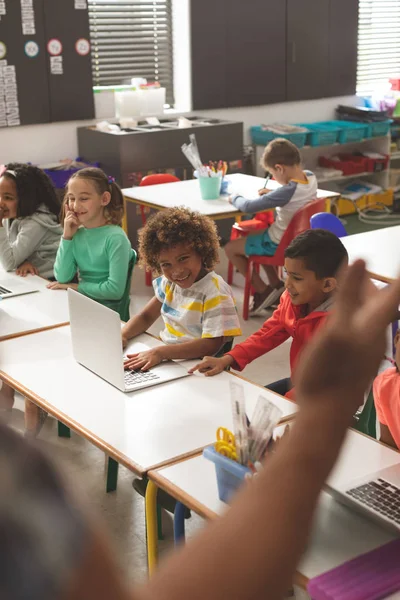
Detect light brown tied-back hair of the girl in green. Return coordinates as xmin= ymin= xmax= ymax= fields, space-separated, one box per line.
xmin=60 ymin=167 xmax=125 ymax=225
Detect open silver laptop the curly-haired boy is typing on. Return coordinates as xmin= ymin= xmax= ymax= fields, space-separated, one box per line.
xmin=68 ymin=289 xmax=189 ymax=392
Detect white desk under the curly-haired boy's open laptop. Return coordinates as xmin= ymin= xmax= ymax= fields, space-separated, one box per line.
xmin=0 ymin=326 xmax=297 ymax=475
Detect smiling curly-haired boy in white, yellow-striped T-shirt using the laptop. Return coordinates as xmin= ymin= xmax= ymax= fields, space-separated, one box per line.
xmin=122 ymin=207 xmax=242 ymax=371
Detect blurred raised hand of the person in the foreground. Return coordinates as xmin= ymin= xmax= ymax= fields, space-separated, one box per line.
xmin=296 ymin=261 xmax=400 ymax=416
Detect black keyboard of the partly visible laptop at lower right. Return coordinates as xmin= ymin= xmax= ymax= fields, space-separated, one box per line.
xmin=346 ymin=479 xmax=400 ymax=525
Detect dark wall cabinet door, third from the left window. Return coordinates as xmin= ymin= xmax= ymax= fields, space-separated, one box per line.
xmin=286 ymin=0 xmax=330 ymax=100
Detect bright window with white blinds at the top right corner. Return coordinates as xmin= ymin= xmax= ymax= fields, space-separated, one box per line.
xmin=358 ymin=0 xmax=400 ymax=95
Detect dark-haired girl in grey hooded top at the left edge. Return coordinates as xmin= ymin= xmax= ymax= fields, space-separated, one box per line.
xmin=0 ymin=163 xmax=62 ymax=279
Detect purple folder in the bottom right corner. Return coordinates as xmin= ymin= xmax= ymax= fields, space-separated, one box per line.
xmin=307 ymin=539 xmax=400 ymax=600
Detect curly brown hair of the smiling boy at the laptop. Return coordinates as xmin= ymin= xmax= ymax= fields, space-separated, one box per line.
xmin=139 ymin=207 xmax=219 ymax=273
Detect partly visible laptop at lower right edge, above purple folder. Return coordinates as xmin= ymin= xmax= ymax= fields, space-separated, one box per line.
xmin=326 ymin=456 xmax=400 ymax=533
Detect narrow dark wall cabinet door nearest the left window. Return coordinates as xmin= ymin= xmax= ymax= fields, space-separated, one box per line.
xmin=190 ymin=0 xmax=229 ymax=110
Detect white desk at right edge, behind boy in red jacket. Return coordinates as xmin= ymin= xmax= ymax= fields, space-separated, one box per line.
xmin=341 ymin=225 xmax=400 ymax=283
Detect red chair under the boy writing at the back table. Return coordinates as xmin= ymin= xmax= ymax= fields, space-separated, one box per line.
xmin=243 ymin=199 xmax=326 ymax=321
